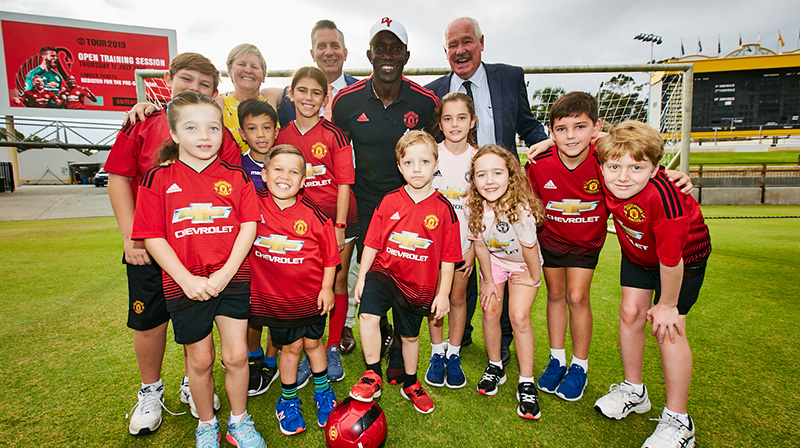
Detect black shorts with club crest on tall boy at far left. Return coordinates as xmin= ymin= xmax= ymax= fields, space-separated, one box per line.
xmin=122 ymin=254 xmax=169 ymax=331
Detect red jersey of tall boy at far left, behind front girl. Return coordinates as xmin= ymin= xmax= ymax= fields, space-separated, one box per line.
xmin=104 ymin=109 xmax=242 ymax=201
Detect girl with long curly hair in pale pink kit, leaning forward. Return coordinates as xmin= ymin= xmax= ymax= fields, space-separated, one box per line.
xmin=467 ymin=145 xmax=544 ymax=420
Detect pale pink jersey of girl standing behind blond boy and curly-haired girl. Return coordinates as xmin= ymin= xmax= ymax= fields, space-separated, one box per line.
xmin=432 ymin=142 xmax=478 ymax=253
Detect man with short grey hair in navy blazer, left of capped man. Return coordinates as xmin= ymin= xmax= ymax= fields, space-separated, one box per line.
xmin=278 ymin=20 xmax=358 ymax=126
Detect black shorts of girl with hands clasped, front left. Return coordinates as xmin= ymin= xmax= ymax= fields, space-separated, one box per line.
xmin=170 ymin=283 xmax=250 ymax=344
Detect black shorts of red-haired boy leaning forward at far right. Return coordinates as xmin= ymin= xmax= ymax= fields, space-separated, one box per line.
xmin=619 ymin=254 xmax=708 ymax=315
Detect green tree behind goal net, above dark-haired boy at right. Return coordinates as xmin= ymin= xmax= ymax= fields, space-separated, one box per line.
xmin=597 ymin=73 xmax=647 ymax=128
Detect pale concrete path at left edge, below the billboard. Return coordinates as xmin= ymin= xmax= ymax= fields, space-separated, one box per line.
xmin=0 ymin=185 xmax=114 ymax=221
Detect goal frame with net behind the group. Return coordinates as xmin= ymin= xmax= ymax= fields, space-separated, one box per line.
xmin=136 ymin=63 xmax=693 ymax=174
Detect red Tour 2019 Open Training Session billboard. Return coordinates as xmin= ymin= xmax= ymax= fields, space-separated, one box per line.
xmin=0 ymin=13 xmax=176 ymax=117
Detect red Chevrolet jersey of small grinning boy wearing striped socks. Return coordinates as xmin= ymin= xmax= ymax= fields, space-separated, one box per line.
xmin=250 ymin=190 xmax=341 ymax=328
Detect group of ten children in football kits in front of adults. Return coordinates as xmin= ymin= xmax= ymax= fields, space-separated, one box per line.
xmin=106 ymin=49 xmax=710 ymax=447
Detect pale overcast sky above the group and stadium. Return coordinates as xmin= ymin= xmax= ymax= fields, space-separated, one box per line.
xmin=0 ymin=0 xmax=800 ymax=90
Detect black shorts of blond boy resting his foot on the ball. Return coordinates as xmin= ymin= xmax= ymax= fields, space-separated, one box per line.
xmin=358 ymin=278 xmax=422 ymax=337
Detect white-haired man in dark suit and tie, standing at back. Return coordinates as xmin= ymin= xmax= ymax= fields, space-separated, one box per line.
xmin=425 ymin=17 xmax=547 ymax=364
